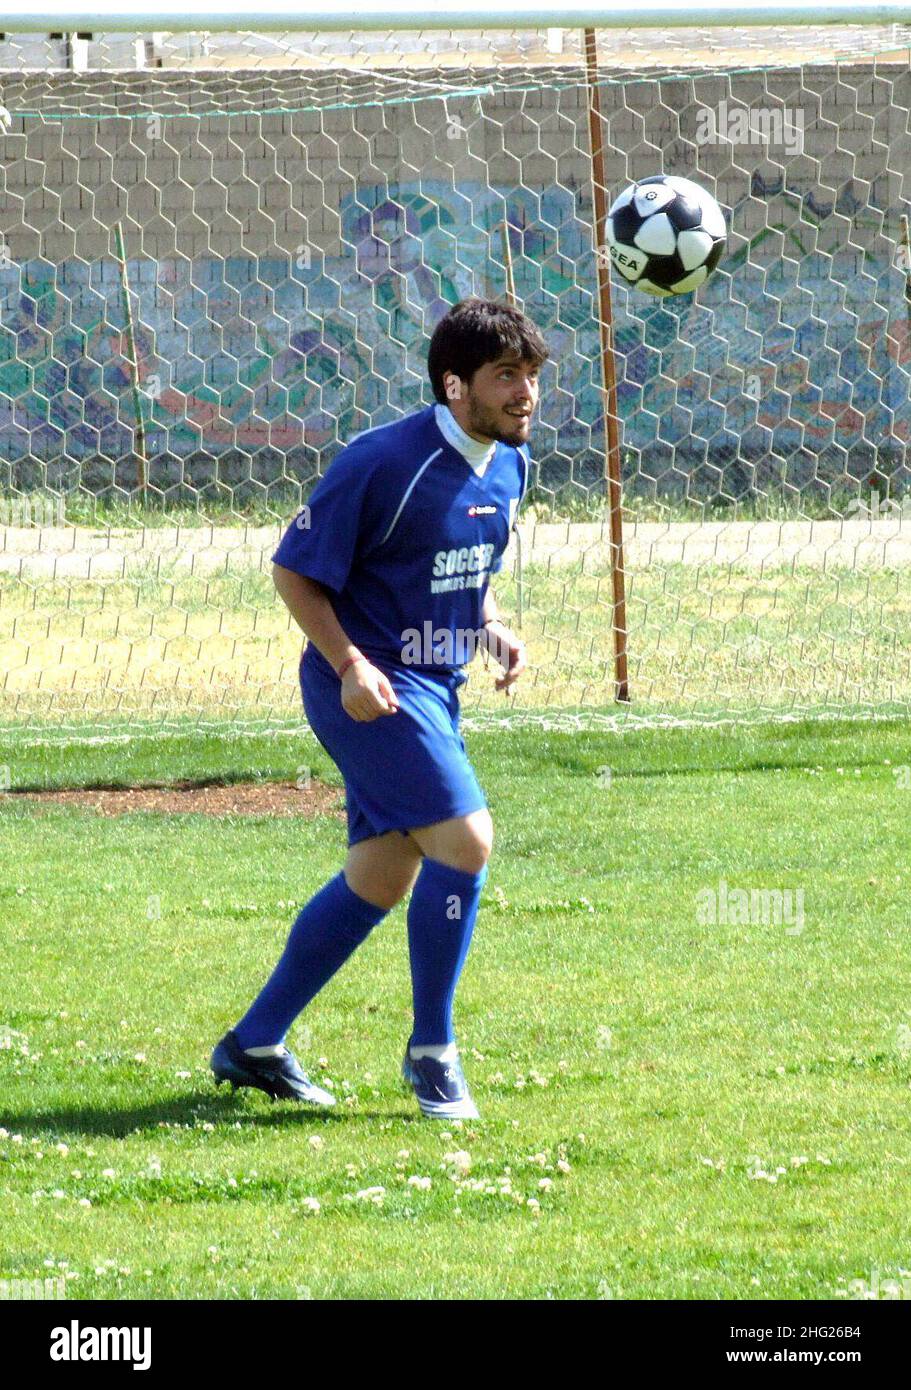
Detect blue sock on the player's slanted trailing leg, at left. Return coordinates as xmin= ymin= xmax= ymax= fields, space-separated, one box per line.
xmin=234 ymin=873 xmax=389 ymax=1048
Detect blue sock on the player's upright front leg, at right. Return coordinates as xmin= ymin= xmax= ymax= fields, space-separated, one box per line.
xmin=408 ymin=859 xmax=487 ymax=1048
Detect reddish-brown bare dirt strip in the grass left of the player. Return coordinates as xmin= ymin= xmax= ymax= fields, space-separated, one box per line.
xmin=0 ymin=781 xmax=345 ymax=819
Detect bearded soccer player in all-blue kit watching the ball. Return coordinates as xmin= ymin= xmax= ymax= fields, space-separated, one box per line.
xmin=211 ymin=299 xmax=548 ymax=1119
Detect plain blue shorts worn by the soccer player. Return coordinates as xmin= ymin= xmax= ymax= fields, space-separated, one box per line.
xmin=300 ymin=644 xmax=487 ymax=845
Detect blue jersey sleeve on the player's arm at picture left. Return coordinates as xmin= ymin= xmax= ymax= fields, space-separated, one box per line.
xmin=273 ymin=441 xmax=382 ymax=594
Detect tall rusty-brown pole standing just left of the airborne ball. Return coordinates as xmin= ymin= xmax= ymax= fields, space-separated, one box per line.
xmin=584 ymin=29 xmax=630 ymax=703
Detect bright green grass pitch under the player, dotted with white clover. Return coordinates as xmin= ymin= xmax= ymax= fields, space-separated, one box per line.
xmin=0 ymin=721 xmax=911 ymax=1300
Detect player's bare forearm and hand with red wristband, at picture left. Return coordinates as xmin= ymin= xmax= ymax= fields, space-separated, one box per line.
xmin=273 ymin=564 xmax=398 ymax=723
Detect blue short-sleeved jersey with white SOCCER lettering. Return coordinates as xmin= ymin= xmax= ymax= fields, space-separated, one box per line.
xmin=273 ymin=406 xmax=529 ymax=671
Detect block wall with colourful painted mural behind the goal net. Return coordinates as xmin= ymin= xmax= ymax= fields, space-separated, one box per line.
xmin=0 ymin=67 xmax=911 ymax=503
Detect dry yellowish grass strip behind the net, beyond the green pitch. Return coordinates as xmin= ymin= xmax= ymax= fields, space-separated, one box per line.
xmin=0 ymin=557 xmax=911 ymax=724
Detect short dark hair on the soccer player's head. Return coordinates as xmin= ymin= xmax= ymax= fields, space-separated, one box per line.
xmin=427 ymin=299 xmax=549 ymax=404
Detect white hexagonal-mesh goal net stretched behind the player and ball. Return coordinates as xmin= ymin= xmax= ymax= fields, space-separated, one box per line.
xmin=0 ymin=6 xmax=911 ymax=737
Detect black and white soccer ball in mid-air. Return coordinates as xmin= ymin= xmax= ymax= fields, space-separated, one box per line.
xmin=606 ymin=174 xmax=726 ymax=295
